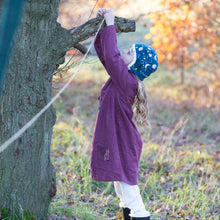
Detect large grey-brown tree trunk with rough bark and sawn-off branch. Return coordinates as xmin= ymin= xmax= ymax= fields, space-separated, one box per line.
xmin=0 ymin=0 xmax=135 ymax=220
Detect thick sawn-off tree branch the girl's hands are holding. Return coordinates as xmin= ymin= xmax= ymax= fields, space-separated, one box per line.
xmin=70 ymin=17 xmax=135 ymax=45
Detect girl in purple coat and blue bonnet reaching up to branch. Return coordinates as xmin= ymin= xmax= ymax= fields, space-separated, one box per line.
xmin=91 ymin=9 xmax=158 ymax=220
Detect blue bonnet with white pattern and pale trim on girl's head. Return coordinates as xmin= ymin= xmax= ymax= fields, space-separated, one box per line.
xmin=128 ymin=44 xmax=158 ymax=81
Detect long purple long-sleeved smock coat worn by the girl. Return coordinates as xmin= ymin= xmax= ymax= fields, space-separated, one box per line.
xmin=90 ymin=25 xmax=143 ymax=185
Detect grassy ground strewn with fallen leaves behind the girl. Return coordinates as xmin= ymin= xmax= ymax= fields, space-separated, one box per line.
xmin=48 ymin=52 xmax=220 ymax=220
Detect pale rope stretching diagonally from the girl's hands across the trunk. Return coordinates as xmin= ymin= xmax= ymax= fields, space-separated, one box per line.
xmin=0 ymin=19 xmax=104 ymax=153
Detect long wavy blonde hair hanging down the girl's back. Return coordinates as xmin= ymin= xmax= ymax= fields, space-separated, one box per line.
xmin=132 ymin=78 xmax=150 ymax=128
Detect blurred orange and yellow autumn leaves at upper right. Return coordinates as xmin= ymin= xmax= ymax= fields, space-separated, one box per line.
xmin=145 ymin=0 xmax=220 ymax=86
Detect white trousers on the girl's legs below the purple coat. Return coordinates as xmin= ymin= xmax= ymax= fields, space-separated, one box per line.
xmin=114 ymin=181 xmax=150 ymax=217
